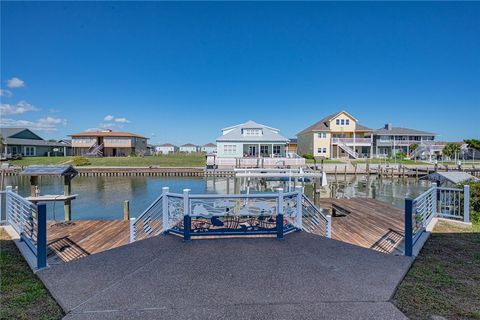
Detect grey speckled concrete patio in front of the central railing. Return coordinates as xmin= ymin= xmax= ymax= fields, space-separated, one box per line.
xmin=38 ymin=232 xmax=411 ymax=320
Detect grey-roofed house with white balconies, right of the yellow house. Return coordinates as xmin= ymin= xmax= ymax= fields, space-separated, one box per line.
xmin=373 ymin=123 xmax=436 ymax=157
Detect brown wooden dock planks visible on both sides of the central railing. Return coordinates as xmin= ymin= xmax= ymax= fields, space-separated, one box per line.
xmin=47 ymin=198 xmax=404 ymax=264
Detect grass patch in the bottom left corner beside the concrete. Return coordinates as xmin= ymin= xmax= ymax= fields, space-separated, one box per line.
xmin=0 ymin=228 xmax=63 ymax=320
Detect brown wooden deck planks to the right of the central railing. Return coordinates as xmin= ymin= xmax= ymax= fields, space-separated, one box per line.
xmin=320 ymin=198 xmax=404 ymax=253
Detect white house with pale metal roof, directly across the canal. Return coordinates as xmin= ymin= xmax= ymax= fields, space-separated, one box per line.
xmin=217 ymin=121 xmax=289 ymax=158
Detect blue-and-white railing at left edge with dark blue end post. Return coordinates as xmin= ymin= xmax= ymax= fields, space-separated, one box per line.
xmin=2 ymin=187 xmax=47 ymax=269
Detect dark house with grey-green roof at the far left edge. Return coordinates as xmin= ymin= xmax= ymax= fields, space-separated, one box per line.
xmin=0 ymin=128 xmax=71 ymax=158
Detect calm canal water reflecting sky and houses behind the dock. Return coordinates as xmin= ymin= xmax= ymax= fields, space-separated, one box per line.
xmin=5 ymin=176 xmax=429 ymax=220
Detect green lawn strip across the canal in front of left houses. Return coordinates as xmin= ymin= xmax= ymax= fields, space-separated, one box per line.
xmin=10 ymin=153 xmax=205 ymax=167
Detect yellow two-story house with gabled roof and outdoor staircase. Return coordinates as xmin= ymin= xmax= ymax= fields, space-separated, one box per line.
xmin=297 ymin=111 xmax=373 ymax=159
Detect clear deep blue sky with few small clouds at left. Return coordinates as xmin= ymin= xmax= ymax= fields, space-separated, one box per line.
xmin=0 ymin=1 xmax=480 ymax=144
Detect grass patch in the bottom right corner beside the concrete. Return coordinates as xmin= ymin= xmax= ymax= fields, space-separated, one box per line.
xmin=393 ymin=221 xmax=480 ymax=319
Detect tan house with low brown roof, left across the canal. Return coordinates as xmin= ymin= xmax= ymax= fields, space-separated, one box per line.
xmin=69 ymin=130 xmax=147 ymax=157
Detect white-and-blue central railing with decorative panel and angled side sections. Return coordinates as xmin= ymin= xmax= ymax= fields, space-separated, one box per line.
xmin=130 ymin=186 xmax=331 ymax=242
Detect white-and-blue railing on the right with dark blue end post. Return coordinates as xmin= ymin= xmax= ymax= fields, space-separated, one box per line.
xmin=405 ymin=183 xmax=470 ymax=256
